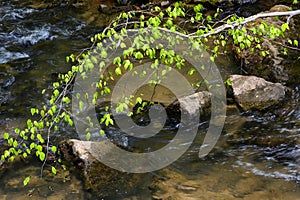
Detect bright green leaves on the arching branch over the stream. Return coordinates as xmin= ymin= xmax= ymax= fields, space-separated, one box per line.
xmin=1 ymin=2 xmax=298 ymax=185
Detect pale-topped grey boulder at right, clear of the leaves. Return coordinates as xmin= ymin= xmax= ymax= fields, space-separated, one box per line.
xmin=230 ymin=75 xmax=287 ymax=110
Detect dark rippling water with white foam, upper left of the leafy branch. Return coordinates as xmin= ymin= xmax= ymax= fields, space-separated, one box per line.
xmin=0 ymin=1 xmax=103 ymax=138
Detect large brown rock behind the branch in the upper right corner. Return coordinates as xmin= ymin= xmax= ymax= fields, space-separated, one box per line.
xmin=234 ymin=5 xmax=299 ymax=83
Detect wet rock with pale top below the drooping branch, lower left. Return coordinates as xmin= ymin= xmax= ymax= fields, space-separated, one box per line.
xmin=59 ymin=139 xmax=148 ymax=198
